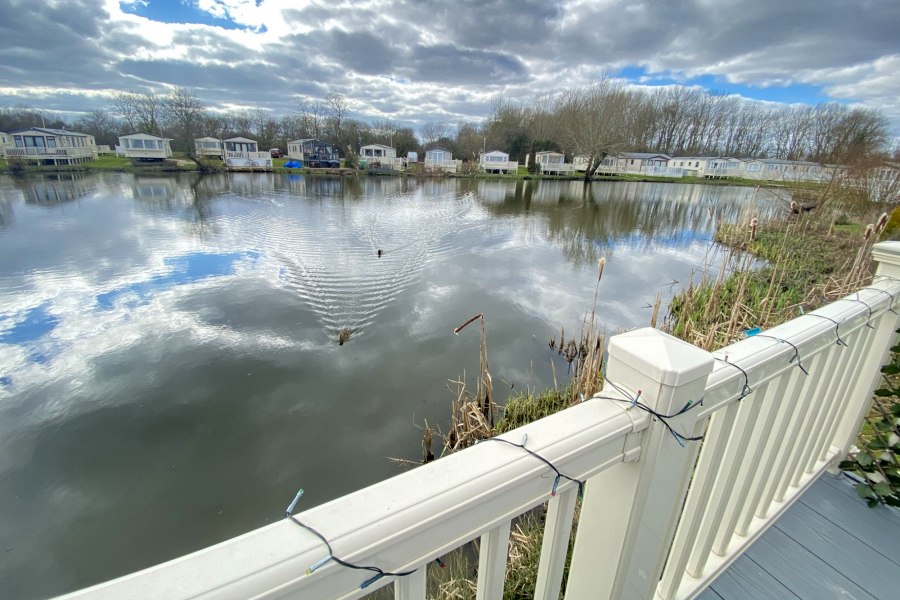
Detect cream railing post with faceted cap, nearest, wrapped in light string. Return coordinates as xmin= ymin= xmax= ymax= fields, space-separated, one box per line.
xmin=566 ymin=327 xmax=713 ymax=600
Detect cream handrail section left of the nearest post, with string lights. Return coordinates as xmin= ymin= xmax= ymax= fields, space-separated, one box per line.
xmin=58 ymin=400 xmax=649 ymax=600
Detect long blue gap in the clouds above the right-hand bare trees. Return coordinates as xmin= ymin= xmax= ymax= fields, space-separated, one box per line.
xmin=616 ymin=67 xmax=840 ymax=104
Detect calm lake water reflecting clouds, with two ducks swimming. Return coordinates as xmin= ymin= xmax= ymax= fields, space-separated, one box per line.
xmin=0 ymin=174 xmax=767 ymax=598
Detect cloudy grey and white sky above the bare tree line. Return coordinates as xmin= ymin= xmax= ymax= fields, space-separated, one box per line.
xmin=0 ymin=0 xmax=900 ymax=136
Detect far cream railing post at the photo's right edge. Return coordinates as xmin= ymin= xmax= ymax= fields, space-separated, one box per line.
xmin=825 ymin=242 xmax=900 ymax=466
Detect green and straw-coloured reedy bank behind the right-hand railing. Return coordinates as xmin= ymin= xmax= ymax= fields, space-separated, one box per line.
xmin=664 ymin=206 xmax=888 ymax=350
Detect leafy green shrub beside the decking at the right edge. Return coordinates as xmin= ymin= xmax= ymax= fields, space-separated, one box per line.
xmin=840 ymin=329 xmax=900 ymax=506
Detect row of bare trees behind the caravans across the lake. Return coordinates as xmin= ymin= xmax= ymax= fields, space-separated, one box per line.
xmin=0 ymin=79 xmax=890 ymax=176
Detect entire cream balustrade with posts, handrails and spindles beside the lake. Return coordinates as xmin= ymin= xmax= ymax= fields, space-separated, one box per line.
xmin=54 ymin=242 xmax=900 ymax=600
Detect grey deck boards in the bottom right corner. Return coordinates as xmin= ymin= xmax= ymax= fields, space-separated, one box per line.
xmin=698 ymin=474 xmax=900 ymax=600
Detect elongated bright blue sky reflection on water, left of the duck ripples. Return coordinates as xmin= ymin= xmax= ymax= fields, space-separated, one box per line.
xmin=97 ymin=251 xmax=259 ymax=309
